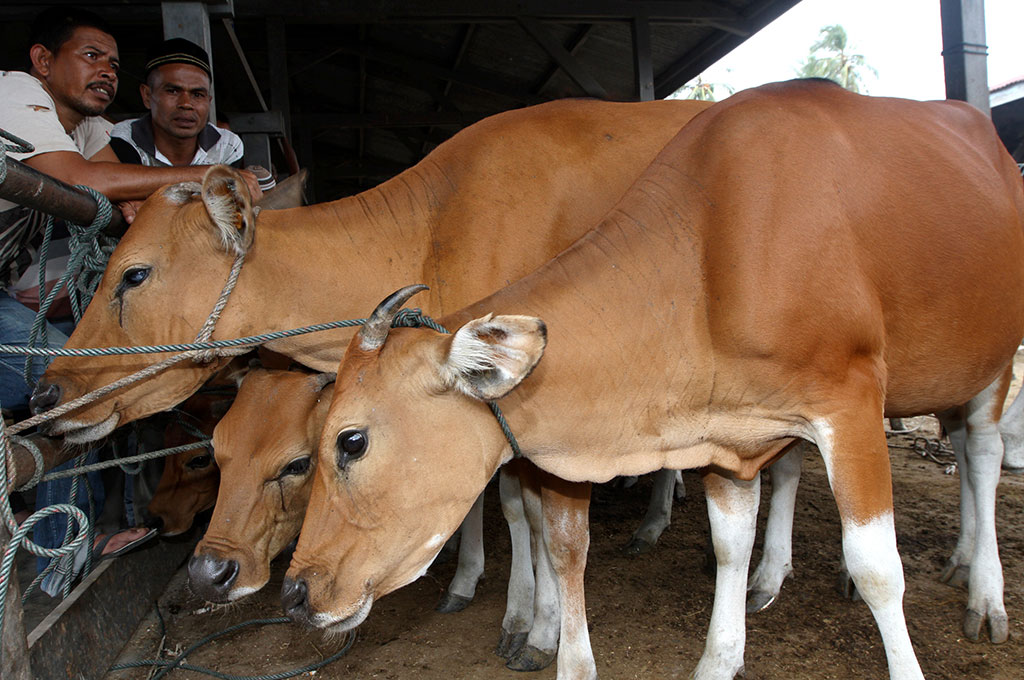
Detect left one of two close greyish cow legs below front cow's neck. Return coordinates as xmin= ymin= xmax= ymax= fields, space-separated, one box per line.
xmin=495 ymin=461 xmax=535 ymax=658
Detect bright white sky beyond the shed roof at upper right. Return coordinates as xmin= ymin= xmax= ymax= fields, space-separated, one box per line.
xmin=679 ymin=0 xmax=1024 ymax=99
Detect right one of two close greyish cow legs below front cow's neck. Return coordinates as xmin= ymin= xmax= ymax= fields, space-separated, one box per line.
xmin=506 ymin=462 xmax=561 ymax=671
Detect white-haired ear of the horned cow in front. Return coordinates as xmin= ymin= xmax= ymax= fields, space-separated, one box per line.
xmin=441 ymin=314 xmax=548 ymax=401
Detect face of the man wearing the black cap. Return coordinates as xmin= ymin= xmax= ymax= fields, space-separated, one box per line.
xmin=141 ymin=63 xmax=210 ymax=139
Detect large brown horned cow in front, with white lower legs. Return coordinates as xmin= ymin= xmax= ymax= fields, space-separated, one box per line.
xmin=283 ymin=82 xmax=1024 ymax=680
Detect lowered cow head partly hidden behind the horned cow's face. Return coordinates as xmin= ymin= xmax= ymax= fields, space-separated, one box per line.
xmin=188 ymin=370 xmax=334 ymax=602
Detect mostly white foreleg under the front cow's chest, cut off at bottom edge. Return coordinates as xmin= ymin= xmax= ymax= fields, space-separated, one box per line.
xmin=692 ymin=471 xmax=761 ymax=680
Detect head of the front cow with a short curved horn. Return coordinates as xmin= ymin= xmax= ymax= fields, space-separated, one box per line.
xmin=282 ymin=287 xmax=545 ymax=632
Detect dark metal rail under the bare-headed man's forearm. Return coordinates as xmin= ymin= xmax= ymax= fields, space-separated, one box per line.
xmin=0 ymin=157 xmax=128 ymax=237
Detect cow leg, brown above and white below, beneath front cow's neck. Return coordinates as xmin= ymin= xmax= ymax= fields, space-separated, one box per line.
xmin=538 ymin=470 xmax=597 ymax=680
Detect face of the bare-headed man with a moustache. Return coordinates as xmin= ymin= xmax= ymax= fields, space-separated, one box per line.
xmin=43 ymin=26 xmax=121 ymax=116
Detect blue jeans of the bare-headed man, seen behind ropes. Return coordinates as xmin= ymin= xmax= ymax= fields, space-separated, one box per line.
xmin=0 ymin=291 xmax=104 ymax=571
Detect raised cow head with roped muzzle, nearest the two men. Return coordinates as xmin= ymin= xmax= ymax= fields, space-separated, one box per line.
xmin=32 ymin=166 xmax=255 ymax=442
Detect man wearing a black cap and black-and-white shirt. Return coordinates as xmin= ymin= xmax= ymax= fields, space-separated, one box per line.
xmin=111 ymin=38 xmax=273 ymax=190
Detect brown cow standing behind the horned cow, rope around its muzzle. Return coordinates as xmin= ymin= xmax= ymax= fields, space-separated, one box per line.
xmin=25 ymin=100 xmax=707 ymax=441
